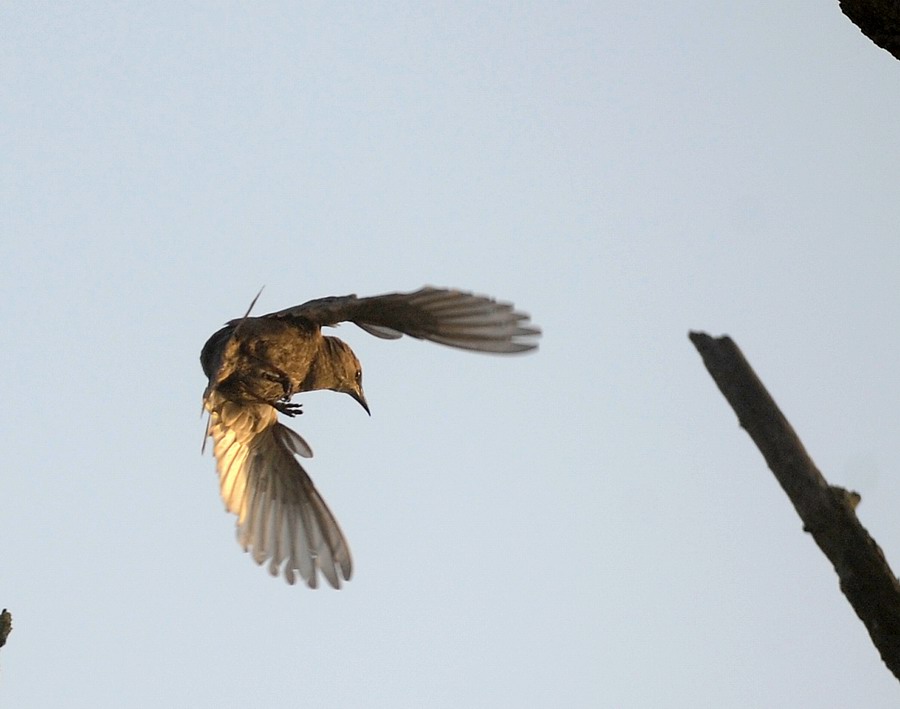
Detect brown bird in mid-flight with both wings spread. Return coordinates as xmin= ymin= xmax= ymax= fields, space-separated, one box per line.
xmin=200 ymin=286 xmax=541 ymax=589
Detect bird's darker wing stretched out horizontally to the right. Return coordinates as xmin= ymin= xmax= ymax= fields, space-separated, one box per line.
xmin=266 ymin=287 xmax=541 ymax=354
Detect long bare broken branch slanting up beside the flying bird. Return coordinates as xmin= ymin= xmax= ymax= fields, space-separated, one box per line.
xmin=690 ymin=332 xmax=900 ymax=679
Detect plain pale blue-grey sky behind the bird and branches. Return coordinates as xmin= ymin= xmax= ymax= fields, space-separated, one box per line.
xmin=0 ymin=0 xmax=900 ymax=709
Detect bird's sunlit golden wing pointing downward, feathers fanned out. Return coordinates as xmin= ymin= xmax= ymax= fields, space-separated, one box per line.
xmin=205 ymin=391 xmax=352 ymax=588
